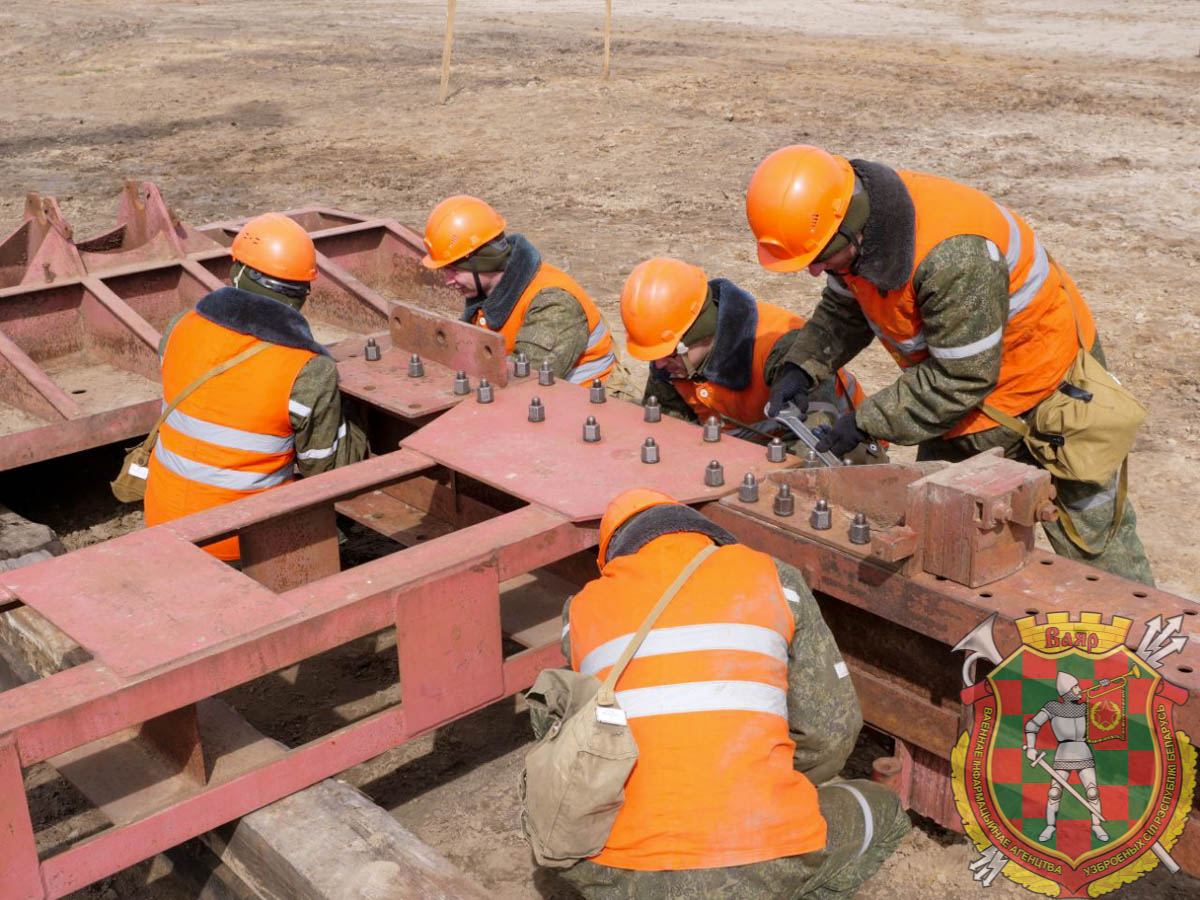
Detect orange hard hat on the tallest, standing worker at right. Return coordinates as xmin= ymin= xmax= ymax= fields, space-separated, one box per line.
xmin=746 ymin=144 xmax=854 ymax=272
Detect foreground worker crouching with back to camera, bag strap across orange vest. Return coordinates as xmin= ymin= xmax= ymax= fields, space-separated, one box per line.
xmin=530 ymin=488 xmax=910 ymax=898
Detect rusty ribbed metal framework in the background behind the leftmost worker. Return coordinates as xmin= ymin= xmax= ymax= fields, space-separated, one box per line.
xmin=0 ymin=192 xmax=458 ymax=470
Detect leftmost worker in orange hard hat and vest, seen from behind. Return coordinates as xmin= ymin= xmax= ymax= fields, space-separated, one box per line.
xmin=145 ymin=212 xmax=366 ymax=563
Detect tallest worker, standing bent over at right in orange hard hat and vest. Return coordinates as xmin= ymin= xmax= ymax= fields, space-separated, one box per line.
xmin=746 ymin=145 xmax=1153 ymax=584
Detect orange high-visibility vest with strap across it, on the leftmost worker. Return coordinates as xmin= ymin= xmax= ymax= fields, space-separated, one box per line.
xmin=145 ymin=311 xmax=314 ymax=559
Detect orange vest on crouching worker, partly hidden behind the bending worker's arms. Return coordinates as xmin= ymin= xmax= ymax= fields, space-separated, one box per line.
xmin=671 ymin=300 xmax=866 ymax=428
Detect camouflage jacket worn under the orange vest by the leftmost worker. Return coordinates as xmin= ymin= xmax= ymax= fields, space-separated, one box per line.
xmin=158 ymin=289 xmax=367 ymax=476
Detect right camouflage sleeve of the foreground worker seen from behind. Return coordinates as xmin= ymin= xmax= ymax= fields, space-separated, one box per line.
xmin=775 ymin=559 xmax=863 ymax=785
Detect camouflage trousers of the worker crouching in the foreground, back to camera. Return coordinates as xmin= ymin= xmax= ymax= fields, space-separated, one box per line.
xmin=559 ymin=780 xmax=911 ymax=900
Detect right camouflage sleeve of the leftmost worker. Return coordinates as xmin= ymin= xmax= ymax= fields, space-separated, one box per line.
xmin=288 ymin=356 xmax=367 ymax=478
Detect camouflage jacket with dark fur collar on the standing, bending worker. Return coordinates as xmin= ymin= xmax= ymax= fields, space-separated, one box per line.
xmin=786 ymin=160 xmax=1008 ymax=444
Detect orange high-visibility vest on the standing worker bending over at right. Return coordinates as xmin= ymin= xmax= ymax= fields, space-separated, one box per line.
xmin=829 ymin=170 xmax=1096 ymax=438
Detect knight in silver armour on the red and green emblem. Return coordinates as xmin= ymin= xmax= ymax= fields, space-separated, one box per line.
xmin=1025 ymin=672 xmax=1109 ymax=844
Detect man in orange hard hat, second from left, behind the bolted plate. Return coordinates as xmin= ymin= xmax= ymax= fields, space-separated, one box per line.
xmin=421 ymin=194 xmax=631 ymax=398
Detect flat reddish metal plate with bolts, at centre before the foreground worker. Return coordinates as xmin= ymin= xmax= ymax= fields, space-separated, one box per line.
xmin=403 ymin=378 xmax=780 ymax=522
